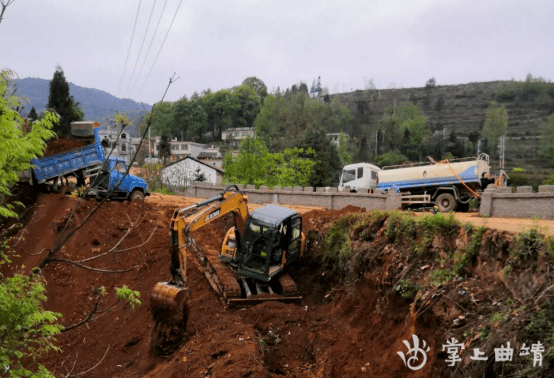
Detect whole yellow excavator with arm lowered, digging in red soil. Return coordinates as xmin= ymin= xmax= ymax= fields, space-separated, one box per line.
xmin=151 ymin=185 xmax=305 ymax=329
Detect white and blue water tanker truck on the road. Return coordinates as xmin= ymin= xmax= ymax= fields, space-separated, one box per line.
xmin=339 ymin=154 xmax=500 ymax=212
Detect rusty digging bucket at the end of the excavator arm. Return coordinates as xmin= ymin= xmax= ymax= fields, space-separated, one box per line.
xmin=150 ymin=282 xmax=188 ymax=329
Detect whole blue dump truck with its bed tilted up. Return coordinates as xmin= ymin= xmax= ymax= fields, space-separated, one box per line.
xmin=31 ymin=122 xmax=149 ymax=201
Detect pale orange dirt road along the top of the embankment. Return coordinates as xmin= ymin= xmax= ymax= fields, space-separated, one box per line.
xmin=147 ymin=193 xmax=554 ymax=235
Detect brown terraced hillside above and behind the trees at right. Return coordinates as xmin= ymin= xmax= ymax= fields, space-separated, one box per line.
xmin=331 ymin=81 xmax=552 ymax=171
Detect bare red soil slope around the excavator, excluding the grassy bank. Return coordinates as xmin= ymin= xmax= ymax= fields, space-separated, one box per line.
xmin=7 ymin=194 xmax=448 ymax=378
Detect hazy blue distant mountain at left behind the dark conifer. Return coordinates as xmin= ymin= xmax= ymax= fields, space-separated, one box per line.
xmin=14 ymin=77 xmax=152 ymax=134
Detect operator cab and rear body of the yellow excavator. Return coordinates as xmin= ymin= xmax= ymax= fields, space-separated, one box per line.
xmin=237 ymin=205 xmax=303 ymax=282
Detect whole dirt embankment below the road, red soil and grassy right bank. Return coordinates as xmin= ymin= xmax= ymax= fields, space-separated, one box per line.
xmin=4 ymin=194 xmax=550 ymax=378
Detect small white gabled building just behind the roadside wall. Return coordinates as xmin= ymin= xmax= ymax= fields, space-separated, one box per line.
xmin=161 ymin=157 xmax=223 ymax=187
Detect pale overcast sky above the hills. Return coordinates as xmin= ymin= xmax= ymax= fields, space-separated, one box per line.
xmin=0 ymin=0 xmax=554 ymax=104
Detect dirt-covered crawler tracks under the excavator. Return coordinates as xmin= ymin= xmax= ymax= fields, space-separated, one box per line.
xmin=196 ymin=250 xmax=302 ymax=306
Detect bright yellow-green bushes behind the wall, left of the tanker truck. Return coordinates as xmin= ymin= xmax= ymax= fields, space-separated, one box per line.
xmin=223 ymin=138 xmax=316 ymax=188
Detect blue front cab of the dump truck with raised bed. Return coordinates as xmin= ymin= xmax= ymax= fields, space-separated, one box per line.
xmin=89 ymin=157 xmax=150 ymax=201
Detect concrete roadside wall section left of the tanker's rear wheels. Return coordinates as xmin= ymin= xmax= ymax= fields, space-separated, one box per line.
xmin=185 ymin=182 xmax=401 ymax=211
